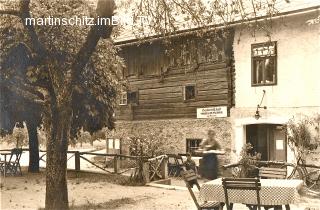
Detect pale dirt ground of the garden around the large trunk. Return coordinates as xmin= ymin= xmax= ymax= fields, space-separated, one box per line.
xmin=0 ymin=171 xmax=320 ymax=210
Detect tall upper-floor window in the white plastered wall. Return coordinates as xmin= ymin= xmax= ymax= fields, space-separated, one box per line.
xmin=251 ymin=42 xmax=277 ymax=86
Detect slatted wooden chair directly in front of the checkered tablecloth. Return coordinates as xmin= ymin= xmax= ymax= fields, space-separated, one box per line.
xmin=222 ymin=178 xmax=261 ymax=210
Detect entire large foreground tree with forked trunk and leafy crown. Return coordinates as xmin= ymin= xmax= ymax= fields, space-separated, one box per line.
xmin=0 ymin=0 xmax=122 ymax=209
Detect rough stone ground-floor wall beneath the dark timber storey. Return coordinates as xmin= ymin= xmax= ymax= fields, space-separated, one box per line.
xmin=106 ymin=118 xmax=232 ymax=164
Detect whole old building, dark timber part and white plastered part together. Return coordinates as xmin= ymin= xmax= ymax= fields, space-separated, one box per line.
xmin=107 ymin=2 xmax=320 ymax=164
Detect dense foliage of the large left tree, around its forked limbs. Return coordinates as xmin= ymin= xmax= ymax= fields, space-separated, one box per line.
xmin=0 ymin=0 xmax=124 ymax=141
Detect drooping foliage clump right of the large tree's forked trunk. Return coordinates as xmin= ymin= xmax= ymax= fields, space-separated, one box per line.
xmin=71 ymin=40 xmax=124 ymax=137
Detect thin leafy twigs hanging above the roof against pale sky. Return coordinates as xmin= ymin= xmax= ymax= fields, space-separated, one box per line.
xmin=126 ymin=0 xmax=288 ymax=39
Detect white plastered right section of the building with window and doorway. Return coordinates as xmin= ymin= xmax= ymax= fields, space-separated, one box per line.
xmin=230 ymin=3 xmax=320 ymax=164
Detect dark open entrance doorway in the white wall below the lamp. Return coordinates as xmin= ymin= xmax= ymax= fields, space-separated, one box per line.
xmin=246 ymin=124 xmax=287 ymax=161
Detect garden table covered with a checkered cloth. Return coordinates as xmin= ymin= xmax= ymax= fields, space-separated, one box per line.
xmin=199 ymin=178 xmax=303 ymax=209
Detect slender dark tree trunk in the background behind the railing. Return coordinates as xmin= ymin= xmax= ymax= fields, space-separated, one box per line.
xmin=27 ymin=122 xmax=39 ymax=172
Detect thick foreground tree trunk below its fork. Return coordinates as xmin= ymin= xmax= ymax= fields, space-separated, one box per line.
xmin=45 ymin=105 xmax=72 ymax=210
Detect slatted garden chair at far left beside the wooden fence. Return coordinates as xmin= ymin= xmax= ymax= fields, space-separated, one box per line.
xmin=1 ymin=148 xmax=22 ymax=176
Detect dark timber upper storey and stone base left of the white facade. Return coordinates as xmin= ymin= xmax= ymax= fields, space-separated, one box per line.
xmin=108 ymin=30 xmax=234 ymax=162
